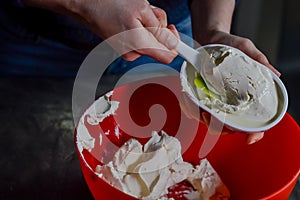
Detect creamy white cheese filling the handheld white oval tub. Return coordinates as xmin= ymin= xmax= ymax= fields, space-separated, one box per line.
xmin=184 ymin=46 xmax=278 ymax=127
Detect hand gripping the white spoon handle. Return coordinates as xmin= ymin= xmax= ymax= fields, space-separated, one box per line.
xmin=72 ymin=0 xmax=179 ymax=63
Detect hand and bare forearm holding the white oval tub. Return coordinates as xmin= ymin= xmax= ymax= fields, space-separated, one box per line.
xmin=186 ymin=0 xmax=268 ymax=144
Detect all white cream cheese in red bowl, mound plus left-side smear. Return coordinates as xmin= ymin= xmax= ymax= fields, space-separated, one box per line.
xmin=77 ymin=92 xmax=229 ymax=200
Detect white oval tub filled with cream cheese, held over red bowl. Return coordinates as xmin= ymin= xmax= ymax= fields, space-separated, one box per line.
xmin=180 ymin=44 xmax=288 ymax=132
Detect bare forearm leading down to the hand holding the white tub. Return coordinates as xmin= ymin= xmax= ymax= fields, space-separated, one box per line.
xmin=191 ymin=0 xmax=235 ymax=44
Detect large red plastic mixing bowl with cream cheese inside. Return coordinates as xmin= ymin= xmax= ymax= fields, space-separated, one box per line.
xmin=75 ymin=76 xmax=300 ymax=200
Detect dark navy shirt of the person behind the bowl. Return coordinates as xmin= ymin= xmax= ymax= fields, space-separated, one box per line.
xmin=0 ymin=0 xmax=189 ymax=49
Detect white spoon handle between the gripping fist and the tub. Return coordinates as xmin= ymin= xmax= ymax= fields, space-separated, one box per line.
xmin=176 ymin=40 xmax=200 ymax=71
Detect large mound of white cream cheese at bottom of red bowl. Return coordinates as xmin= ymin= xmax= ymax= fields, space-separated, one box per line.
xmin=96 ymin=132 xmax=229 ymax=200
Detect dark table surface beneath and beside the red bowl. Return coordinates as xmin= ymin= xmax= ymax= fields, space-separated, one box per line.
xmin=0 ymin=77 xmax=300 ymax=200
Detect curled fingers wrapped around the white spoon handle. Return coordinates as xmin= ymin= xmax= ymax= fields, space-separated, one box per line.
xmin=126 ymin=5 xmax=178 ymax=64
